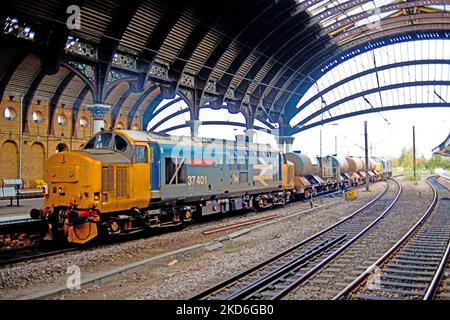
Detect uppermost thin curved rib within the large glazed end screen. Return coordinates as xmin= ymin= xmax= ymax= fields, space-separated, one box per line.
xmin=292 ymin=59 xmax=450 ymax=117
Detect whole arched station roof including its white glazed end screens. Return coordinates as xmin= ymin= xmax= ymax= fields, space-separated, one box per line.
xmin=0 ymin=0 xmax=450 ymax=135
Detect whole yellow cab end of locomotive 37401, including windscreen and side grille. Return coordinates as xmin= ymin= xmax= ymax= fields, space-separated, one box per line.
xmin=30 ymin=131 xmax=150 ymax=244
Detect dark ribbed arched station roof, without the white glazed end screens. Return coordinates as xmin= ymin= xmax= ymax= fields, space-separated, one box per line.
xmin=0 ymin=0 xmax=450 ymax=134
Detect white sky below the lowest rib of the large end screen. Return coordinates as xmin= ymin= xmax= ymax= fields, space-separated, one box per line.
xmin=293 ymin=108 xmax=450 ymax=158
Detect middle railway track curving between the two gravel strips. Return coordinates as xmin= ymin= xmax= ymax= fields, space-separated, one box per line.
xmin=191 ymin=179 xmax=401 ymax=300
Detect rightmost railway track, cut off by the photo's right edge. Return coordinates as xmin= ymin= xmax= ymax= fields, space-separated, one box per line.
xmin=334 ymin=177 xmax=450 ymax=300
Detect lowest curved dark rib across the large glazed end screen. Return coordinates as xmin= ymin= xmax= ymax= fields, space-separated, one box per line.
xmin=290 ymin=102 xmax=450 ymax=135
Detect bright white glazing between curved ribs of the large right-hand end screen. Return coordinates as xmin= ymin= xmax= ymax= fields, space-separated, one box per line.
xmin=290 ymin=39 xmax=450 ymax=125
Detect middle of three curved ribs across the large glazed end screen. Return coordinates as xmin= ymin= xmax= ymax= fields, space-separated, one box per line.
xmin=293 ymin=81 xmax=450 ymax=127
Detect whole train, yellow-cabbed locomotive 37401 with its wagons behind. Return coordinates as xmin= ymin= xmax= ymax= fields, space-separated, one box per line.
xmin=30 ymin=129 xmax=387 ymax=244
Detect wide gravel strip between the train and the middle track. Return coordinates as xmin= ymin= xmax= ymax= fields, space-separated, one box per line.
xmin=0 ymin=183 xmax=385 ymax=299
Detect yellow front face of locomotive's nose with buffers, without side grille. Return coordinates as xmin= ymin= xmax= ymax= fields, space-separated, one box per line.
xmin=31 ymin=151 xmax=102 ymax=243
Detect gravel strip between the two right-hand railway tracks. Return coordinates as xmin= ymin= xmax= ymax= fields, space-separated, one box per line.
xmin=286 ymin=178 xmax=433 ymax=300
